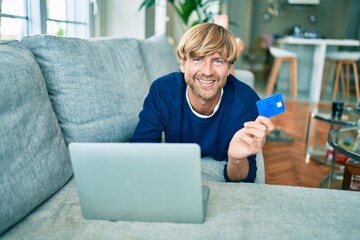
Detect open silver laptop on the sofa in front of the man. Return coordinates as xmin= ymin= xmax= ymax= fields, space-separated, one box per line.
xmin=69 ymin=143 xmax=209 ymax=223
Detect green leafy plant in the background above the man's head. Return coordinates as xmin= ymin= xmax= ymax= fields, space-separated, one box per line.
xmin=139 ymin=0 xmax=221 ymax=28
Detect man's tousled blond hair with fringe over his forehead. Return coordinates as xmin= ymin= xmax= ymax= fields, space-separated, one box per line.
xmin=176 ymin=23 xmax=237 ymax=64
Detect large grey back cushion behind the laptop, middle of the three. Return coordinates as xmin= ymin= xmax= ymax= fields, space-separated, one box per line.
xmin=22 ymin=35 xmax=149 ymax=143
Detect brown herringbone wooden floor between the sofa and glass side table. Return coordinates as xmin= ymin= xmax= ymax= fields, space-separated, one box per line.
xmin=263 ymin=100 xmax=329 ymax=188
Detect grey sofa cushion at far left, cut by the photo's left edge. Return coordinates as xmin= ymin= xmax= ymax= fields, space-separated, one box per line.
xmin=0 ymin=41 xmax=72 ymax=235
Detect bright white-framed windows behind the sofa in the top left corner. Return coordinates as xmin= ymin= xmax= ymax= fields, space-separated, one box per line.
xmin=0 ymin=0 xmax=91 ymax=39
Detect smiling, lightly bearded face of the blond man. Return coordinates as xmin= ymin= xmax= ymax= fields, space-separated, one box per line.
xmin=181 ymin=53 xmax=229 ymax=102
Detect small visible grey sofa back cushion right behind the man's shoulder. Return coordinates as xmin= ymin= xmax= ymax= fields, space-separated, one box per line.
xmin=140 ymin=35 xmax=180 ymax=81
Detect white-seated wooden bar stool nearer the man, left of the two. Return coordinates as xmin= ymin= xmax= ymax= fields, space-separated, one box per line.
xmin=266 ymin=47 xmax=297 ymax=97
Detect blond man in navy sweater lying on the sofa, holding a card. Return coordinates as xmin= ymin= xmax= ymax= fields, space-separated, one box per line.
xmin=132 ymin=23 xmax=274 ymax=182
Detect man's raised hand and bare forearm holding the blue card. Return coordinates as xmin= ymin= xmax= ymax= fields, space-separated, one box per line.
xmin=228 ymin=116 xmax=275 ymax=181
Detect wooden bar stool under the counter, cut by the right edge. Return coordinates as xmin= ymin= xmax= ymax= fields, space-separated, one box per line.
xmin=321 ymin=51 xmax=360 ymax=100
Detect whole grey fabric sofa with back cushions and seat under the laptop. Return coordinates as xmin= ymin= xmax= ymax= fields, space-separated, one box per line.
xmin=0 ymin=33 xmax=360 ymax=240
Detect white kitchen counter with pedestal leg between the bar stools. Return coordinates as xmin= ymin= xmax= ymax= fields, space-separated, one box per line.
xmin=277 ymin=37 xmax=360 ymax=102
